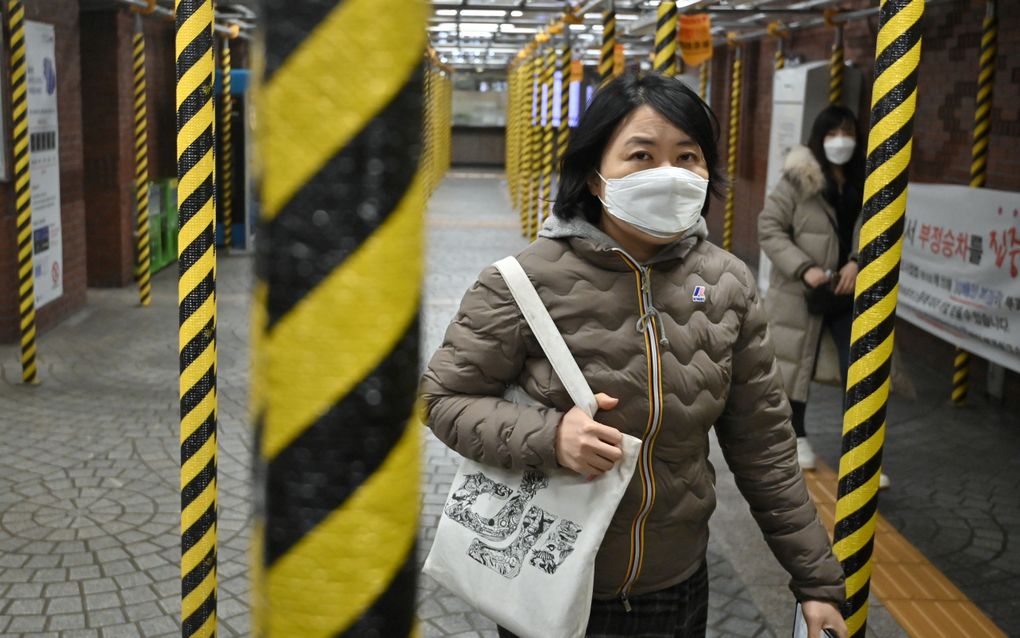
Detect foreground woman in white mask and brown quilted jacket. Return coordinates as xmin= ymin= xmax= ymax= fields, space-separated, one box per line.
xmin=422 ymin=73 xmax=847 ymax=638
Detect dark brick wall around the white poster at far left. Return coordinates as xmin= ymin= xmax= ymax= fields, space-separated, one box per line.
xmin=0 ymin=0 xmax=86 ymax=342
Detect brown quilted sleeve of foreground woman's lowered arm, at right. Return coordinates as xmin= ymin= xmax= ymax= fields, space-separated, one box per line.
xmin=716 ymin=266 xmax=845 ymax=604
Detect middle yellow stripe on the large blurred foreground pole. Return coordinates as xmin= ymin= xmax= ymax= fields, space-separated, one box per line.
xmin=262 ymin=171 xmax=424 ymax=461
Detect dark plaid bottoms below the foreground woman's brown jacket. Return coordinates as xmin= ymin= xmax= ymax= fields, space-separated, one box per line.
xmin=498 ymin=562 xmax=708 ymax=638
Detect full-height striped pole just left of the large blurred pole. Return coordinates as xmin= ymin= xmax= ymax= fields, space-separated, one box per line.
xmin=176 ymin=0 xmax=216 ymax=636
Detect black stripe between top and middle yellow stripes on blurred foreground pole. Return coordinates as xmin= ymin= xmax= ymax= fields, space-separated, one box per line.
xmin=256 ymin=66 xmax=423 ymax=330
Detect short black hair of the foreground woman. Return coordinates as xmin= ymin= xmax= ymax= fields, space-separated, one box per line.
xmin=553 ymin=71 xmax=724 ymax=224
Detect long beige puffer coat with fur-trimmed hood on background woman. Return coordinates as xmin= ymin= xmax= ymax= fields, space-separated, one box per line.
xmin=758 ymin=146 xmax=863 ymax=401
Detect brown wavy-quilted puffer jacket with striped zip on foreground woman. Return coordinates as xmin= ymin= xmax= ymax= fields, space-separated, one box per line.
xmin=422 ymin=212 xmax=844 ymax=602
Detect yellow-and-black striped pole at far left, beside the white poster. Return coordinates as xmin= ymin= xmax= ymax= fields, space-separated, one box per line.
xmin=7 ymin=0 xmax=38 ymax=383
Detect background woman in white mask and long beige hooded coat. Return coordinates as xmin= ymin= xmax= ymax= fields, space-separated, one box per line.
xmin=758 ymin=106 xmax=885 ymax=487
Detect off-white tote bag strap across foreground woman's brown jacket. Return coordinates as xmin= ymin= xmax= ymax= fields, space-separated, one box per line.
xmin=494 ymin=256 xmax=598 ymax=416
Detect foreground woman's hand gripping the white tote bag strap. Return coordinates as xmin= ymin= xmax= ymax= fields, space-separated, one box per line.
xmin=556 ymin=392 xmax=623 ymax=479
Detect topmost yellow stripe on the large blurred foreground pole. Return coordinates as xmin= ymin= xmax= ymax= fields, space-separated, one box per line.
xmin=261 ymin=0 xmax=429 ymax=219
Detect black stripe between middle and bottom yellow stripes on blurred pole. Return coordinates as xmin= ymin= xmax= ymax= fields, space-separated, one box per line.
xmin=264 ymin=320 xmax=418 ymax=566
